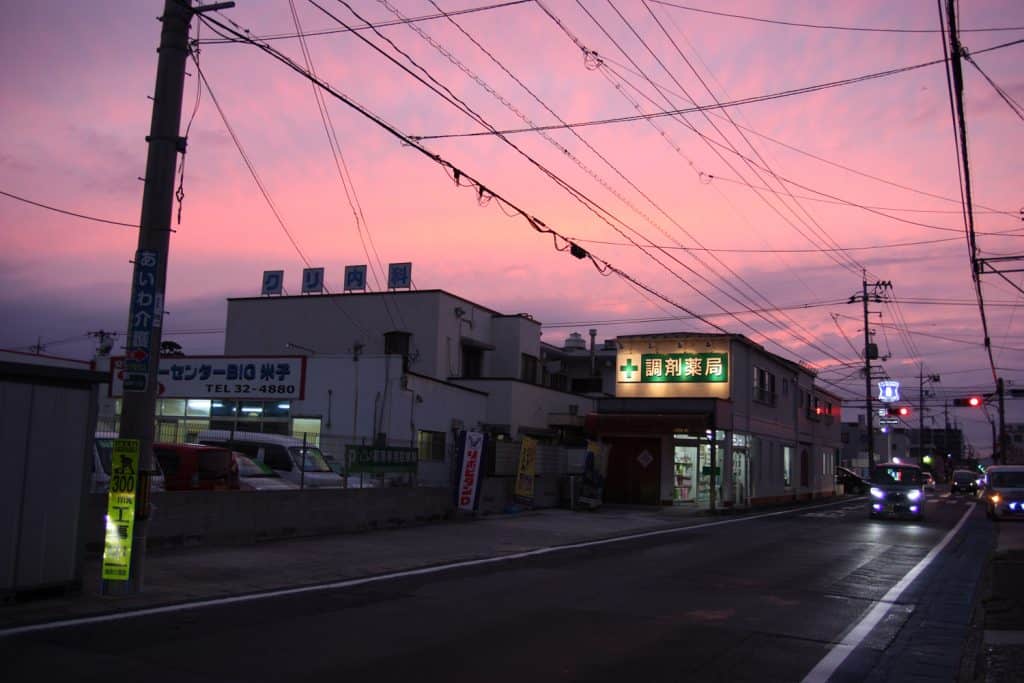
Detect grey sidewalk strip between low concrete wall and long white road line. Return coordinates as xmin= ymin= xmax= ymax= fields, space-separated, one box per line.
xmin=0 ymin=506 xmax=710 ymax=630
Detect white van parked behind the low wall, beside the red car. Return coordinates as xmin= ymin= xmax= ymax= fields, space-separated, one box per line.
xmin=196 ymin=429 xmax=345 ymax=488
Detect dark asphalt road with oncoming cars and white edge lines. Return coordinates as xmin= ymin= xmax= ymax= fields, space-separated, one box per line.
xmin=0 ymin=496 xmax=993 ymax=683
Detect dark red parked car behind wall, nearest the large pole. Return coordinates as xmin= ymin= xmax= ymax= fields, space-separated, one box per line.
xmin=153 ymin=443 xmax=239 ymax=490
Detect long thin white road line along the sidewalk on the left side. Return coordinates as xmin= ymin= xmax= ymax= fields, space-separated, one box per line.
xmin=0 ymin=501 xmax=847 ymax=638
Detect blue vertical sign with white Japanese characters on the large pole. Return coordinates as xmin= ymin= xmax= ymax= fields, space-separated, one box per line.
xmin=124 ymin=250 xmax=164 ymax=391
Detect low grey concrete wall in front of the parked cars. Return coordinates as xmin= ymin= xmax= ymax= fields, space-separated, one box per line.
xmin=83 ymin=487 xmax=455 ymax=552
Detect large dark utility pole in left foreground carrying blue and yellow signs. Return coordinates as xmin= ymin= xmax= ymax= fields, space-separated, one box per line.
xmin=110 ymin=0 xmax=234 ymax=595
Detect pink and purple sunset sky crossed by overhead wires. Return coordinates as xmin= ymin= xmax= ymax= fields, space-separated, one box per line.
xmin=0 ymin=0 xmax=1024 ymax=454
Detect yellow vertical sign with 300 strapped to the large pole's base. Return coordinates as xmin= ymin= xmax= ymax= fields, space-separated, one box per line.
xmin=102 ymin=438 xmax=139 ymax=581
